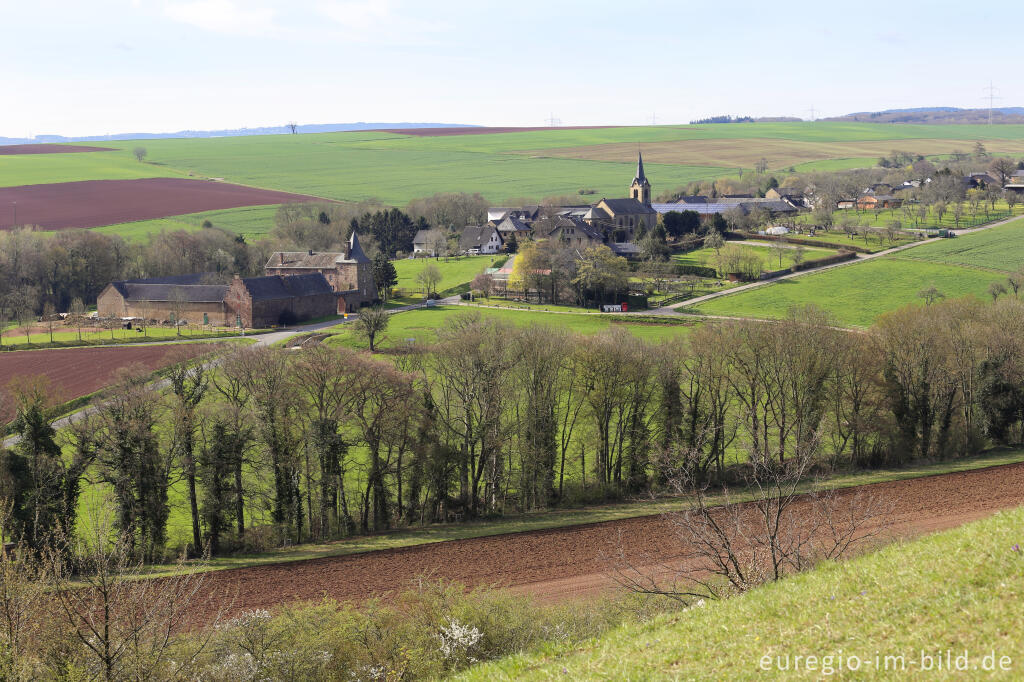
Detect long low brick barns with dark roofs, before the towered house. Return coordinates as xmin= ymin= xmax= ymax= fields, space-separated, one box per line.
xmin=96 ymin=272 xmax=338 ymax=329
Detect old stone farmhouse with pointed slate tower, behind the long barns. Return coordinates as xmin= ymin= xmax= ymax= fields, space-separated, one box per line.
xmin=263 ymin=232 xmax=380 ymax=312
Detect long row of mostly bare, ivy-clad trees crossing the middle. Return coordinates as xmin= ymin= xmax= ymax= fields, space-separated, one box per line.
xmin=2 ymin=296 xmax=1024 ymax=557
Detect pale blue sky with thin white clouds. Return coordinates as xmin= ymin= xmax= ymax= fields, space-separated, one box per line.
xmin=0 ymin=0 xmax=1024 ymax=137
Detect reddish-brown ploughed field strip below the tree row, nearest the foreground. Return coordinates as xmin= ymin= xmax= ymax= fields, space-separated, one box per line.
xmin=196 ymin=464 xmax=1024 ymax=622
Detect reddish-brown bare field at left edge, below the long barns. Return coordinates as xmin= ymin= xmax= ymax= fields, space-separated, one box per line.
xmin=0 ymin=344 xmax=175 ymax=423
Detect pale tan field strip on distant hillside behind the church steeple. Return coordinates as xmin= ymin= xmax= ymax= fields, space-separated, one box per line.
xmin=519 ymin=138 xmax=1024 ymax=168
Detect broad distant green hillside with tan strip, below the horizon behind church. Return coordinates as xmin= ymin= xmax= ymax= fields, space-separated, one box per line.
xmin=6 ymin=122 xmax=1024 ymax=237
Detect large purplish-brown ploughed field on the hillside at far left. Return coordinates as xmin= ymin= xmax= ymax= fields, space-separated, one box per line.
xmin=0 ymin=177 xmax=326 ymax=229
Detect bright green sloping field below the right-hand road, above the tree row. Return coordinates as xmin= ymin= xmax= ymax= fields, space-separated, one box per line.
xmin=695 ymin=256 xmax=1002 ymax=327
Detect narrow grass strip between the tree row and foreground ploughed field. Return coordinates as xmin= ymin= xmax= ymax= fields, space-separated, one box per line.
xmin=136 ymin=450 xmax=1024 ymax=576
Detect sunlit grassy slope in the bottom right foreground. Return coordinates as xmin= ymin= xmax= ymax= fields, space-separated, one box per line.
xmin=462 ymin=508 xmax=1024 ymax=680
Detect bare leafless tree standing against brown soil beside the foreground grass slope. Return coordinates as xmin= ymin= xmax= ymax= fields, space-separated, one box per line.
xmin=612 ymin=450 xmax=894 ymax=603
